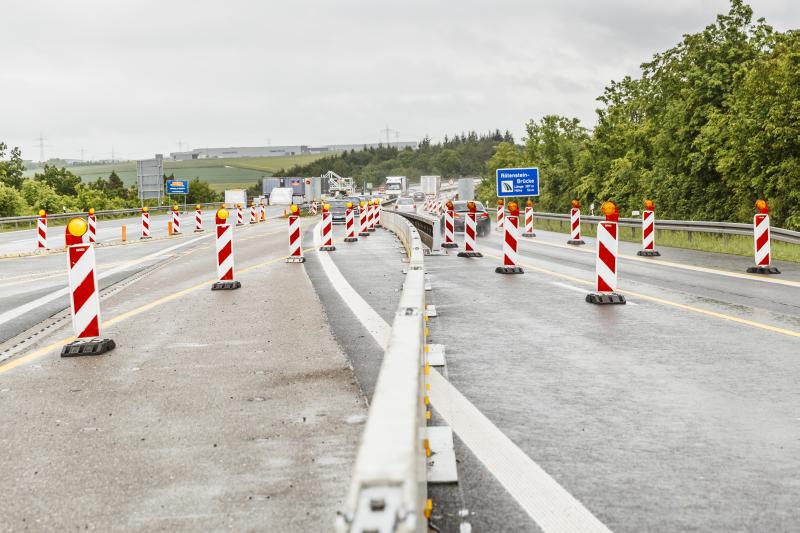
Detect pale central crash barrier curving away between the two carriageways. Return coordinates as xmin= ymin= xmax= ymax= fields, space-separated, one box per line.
xmin=336 ymin=207 xmax=428 ymax=533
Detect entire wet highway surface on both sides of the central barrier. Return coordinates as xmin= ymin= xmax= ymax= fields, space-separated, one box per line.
xmin=0 ymin=205 xmax=800 ymax=532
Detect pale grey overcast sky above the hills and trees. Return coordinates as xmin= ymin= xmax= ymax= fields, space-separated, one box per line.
xmin=0 ymin=0 xmax=800 ymax=160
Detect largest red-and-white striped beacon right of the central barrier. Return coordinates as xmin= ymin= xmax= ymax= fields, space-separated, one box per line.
xmin=586 ymin=201 xmax=625 ymax=304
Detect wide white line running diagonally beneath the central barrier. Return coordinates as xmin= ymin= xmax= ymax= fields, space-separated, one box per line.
xmin=314 ymin=224 xmax=610 ymax=533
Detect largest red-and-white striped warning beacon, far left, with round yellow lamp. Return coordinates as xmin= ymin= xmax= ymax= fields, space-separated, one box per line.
xmin=61 ymin=217 xmax=116 ymax=357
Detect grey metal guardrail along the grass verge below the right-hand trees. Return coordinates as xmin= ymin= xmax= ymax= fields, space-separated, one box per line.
xmin=533 ymin=211 xmax=800 ymax=244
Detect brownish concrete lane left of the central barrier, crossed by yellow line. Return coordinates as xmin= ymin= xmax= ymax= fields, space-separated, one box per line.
xmin=0 ymin=214 xmax=366 ymax=531
